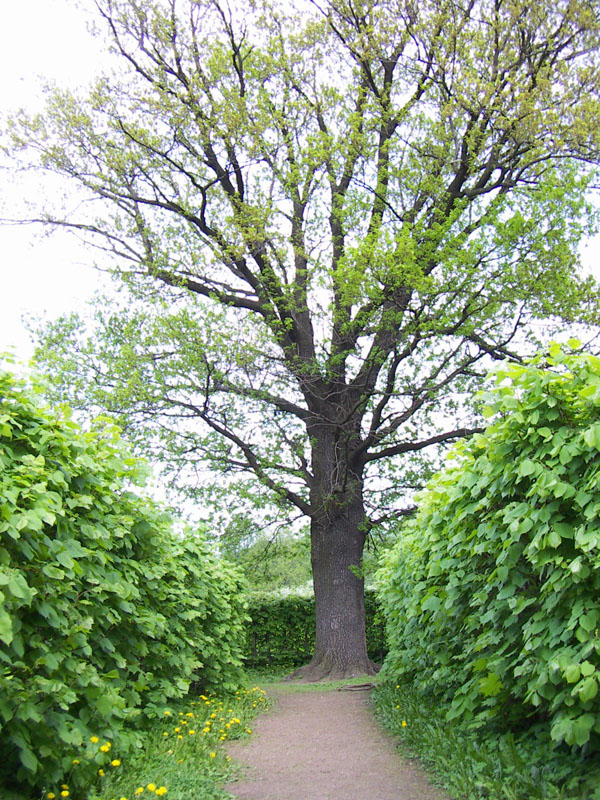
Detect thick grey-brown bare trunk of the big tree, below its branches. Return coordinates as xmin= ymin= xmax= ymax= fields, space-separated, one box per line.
xmin=292 ymin=432 xmax=377 ymax=681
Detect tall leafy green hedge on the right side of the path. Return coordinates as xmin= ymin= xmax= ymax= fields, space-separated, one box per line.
xmin=379 ymin=341 xmax=600 ymax=753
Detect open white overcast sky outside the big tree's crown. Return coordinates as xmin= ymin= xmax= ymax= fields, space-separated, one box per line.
xmin=0 ymin=0 xmax=600 ymax=368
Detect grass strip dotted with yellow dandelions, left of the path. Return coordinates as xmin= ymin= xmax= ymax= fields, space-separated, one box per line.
xmin=35 ymin=687 xmax=267 ymax=800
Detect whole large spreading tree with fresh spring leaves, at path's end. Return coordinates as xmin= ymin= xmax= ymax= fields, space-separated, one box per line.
xmin=7 ymin=0 xmax=600 ymax=677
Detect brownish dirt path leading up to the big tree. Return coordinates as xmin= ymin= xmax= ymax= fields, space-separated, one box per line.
xmin=225 ymin=690 xmax=445 ymax=800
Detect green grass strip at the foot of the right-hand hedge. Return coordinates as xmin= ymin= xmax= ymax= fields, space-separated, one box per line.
xmin=375 ymin=684 xmax=600 ymax=800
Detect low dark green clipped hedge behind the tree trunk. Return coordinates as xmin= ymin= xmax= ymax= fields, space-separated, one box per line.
xmin=244 ymin=590 xmax=387 ymax=668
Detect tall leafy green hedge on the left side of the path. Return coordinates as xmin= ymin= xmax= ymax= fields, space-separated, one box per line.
xmin=0 ymin=372 xmax=244 ymax=786
